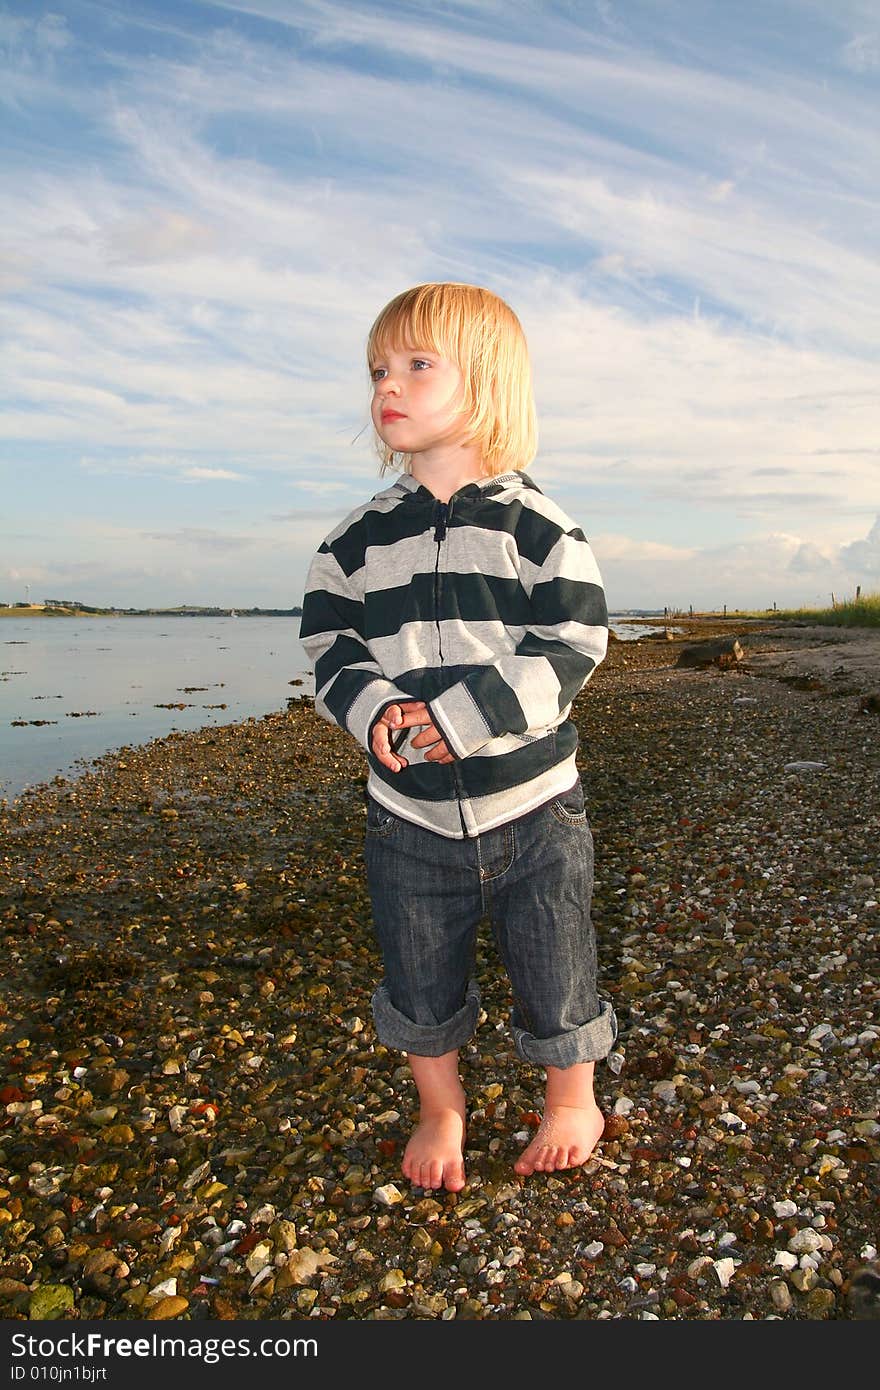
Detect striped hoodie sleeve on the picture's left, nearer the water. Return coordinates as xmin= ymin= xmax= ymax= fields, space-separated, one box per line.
xmin=299 ymin=541 xmax=412 ymax=749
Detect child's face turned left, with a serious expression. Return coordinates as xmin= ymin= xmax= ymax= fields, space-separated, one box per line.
xmin=371 ymin=348 xmax=467 ymax=455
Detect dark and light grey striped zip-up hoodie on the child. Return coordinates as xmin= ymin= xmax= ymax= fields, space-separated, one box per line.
xmin=300 ymin=473 xmax=608 ymax=840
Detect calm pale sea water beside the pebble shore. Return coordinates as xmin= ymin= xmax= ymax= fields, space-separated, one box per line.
xmin=0 ymin=617 xmax=649 ymax=798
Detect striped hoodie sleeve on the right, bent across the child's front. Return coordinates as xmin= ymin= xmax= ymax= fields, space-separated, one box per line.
xmin=430 ymin=517 xmax=608 ymax=758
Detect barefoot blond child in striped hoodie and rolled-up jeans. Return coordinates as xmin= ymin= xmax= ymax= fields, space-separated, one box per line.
xmin=300 ymin=284 xmax=617 ymax=1191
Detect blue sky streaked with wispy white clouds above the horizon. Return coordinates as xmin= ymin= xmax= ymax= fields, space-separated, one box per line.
xmin=0 ymin=0 xmax=880 ymax=609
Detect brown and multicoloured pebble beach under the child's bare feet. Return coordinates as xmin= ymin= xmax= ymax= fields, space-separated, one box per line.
xmin=0 ymin=623 xmax=880 ymax=1322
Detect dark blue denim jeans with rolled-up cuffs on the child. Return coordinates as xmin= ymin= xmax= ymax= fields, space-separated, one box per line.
xmin=364 ymin=780 xmax=617 ymax=1068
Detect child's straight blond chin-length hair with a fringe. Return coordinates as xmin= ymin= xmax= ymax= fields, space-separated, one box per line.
xmin=367 ymin=284 xmax=538 ymax=475
